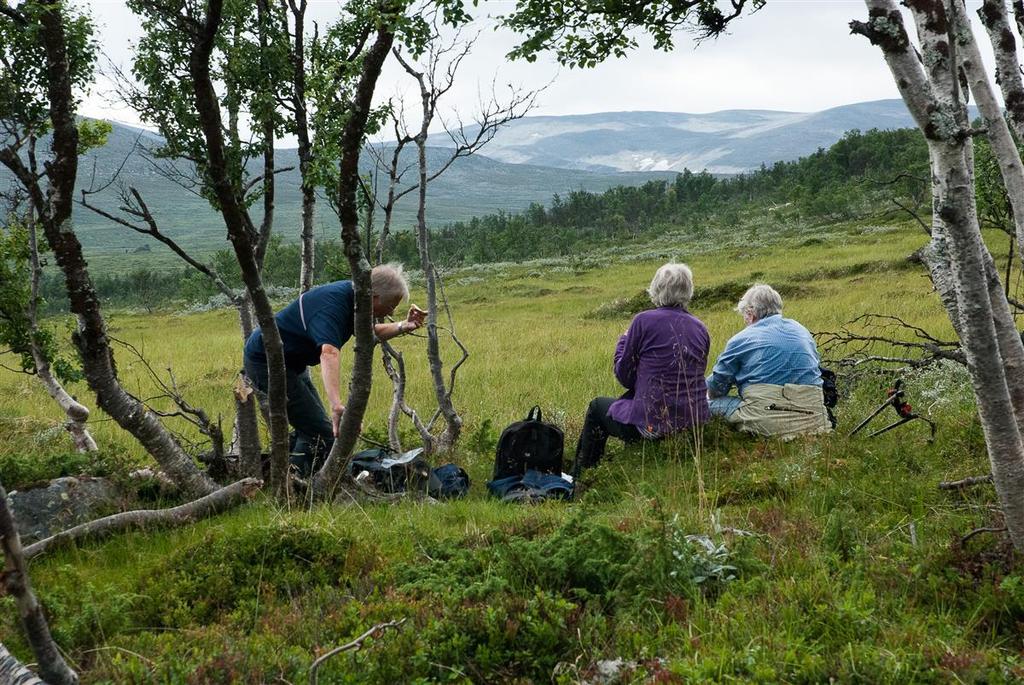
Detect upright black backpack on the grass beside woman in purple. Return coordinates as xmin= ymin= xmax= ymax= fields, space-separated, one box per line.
xmin=492 ymin=406 xmax=565 ymax=480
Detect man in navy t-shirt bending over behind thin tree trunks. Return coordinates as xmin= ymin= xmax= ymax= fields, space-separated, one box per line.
xmin=245 ymin=264 xmax=426 ymax=475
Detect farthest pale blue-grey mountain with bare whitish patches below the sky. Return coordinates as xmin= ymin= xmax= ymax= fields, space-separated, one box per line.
xmin=436 ymin=99 xmax=913 ymax=174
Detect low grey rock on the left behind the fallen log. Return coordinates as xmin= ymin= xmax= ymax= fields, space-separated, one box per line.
xmin=7 ymin=476 xmax=122 ymax=543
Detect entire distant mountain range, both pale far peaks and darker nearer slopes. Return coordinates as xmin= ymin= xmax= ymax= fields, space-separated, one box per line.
xmin=0 ymin=100 xmax=925 ymax=258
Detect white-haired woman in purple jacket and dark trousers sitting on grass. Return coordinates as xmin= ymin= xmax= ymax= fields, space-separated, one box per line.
xmin=573 ymin=262 xmax=711 ymax=473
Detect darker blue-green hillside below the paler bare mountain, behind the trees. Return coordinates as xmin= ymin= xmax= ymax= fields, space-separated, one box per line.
xmin=59 ymin=124 xmax=675 ymax=256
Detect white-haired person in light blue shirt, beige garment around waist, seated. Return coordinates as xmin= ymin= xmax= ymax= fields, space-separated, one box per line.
xmin=708 ymin=284 xmax=831 ymax=438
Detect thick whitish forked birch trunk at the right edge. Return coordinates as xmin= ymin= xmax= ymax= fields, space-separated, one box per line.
xmin=850 ymin=0 xmax=1024 ymax=550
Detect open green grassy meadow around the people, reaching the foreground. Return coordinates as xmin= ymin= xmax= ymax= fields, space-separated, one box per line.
xmin=0 ymin=224 xmax=1024 ymax=683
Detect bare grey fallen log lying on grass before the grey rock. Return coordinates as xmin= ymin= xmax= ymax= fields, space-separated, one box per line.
xmin=25 ymin=478 xmax=263 ymax=559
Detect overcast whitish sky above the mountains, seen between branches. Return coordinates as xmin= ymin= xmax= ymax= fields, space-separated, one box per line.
xmin=82 ymin=0 xmax=991 ymax=135
